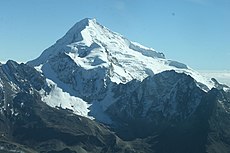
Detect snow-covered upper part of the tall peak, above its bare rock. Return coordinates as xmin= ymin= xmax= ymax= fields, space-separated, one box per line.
xmin=28 ymin=18 xmax=214 ymax=87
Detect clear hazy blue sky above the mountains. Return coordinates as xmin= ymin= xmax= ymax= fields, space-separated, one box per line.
xmin=0 ymin=0 xmax=230 ymax=70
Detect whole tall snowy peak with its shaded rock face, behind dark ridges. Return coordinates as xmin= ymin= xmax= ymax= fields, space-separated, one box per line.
xmin=28 ymin=19 xmax=217 ymax=122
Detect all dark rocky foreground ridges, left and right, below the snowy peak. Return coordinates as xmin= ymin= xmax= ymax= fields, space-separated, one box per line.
xmin=0 ymin=61 xmax=230 ymax=153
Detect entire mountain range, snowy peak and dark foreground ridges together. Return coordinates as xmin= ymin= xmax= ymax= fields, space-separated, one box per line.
xmin=0 ymin=18 xmax=230 ymax=153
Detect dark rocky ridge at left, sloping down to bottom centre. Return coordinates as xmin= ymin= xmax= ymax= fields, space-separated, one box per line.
xmin=0 ymin=61 xmax=149 ymax=153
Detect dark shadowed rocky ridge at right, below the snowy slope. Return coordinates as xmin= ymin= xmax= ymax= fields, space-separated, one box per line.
xmin=104 ymin=71 xmax=230 ymax=153
